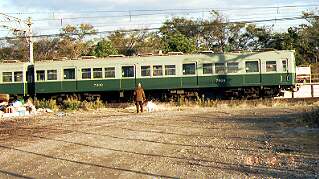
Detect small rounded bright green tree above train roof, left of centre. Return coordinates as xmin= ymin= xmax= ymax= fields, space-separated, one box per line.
xmin=91 ymin=39 xmax=118 ymax=57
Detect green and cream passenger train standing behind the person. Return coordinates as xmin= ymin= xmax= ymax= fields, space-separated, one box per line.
xmin=0 ymin=50 xmax=296 ymax=98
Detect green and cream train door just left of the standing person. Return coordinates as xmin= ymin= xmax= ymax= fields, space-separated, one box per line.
xmin=120 ymin=64 xmax=136 ymax=91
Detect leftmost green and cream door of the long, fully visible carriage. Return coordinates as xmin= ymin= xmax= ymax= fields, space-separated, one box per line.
xmin=60 ymin=66 xmax=78 ymax=92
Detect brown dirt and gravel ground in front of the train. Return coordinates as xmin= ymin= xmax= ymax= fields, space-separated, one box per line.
xmin=0 ymin=107 xmax=319 ymax=178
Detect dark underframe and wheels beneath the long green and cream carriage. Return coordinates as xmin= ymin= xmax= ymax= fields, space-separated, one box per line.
xmin=30 ymin=86 xmax=294 ymax=102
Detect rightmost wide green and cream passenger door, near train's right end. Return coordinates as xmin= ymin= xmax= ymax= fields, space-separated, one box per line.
xmin=244 ymin=60 xmax=262 ymax=86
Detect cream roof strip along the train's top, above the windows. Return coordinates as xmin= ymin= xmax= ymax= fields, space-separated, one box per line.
xmin=0 ymin=50 xmax=294 ymax=66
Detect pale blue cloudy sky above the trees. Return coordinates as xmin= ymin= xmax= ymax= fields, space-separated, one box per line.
xmin=0 ymin=0 xmax=319 ymax=37
